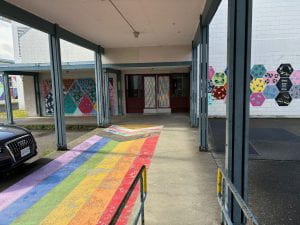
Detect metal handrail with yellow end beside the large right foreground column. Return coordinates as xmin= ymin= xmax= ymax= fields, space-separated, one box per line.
xmin=217 ymin=168 xmax=259 ymax=225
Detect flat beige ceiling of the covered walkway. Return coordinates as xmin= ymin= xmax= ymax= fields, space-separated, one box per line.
xmin=7 ymin=0 xmax=206 ymax=48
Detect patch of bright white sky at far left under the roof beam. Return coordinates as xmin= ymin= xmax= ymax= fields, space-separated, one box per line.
xmin=0 ymin=20 xmax=14 ymax=59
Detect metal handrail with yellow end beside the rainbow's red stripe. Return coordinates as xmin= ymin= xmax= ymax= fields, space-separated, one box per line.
xmin=109 ymin=165 xmax=147 ymax=225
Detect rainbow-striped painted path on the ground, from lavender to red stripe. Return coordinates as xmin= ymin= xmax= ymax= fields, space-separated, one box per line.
xmin=0 ymin=125 xmax=159 ymax=225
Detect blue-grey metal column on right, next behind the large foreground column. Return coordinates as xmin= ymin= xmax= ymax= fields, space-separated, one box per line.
xmin=199 ymin=26 xmax=208 ymax=151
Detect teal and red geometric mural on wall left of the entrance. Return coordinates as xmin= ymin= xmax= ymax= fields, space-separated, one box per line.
xmin=42 ymin=78 xmax=115 ymax=116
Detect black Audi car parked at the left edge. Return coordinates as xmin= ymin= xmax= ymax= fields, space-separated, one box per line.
xmin=0 ymin=124 xmax=37 ymax=171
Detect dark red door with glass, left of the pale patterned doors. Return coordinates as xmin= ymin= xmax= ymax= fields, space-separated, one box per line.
xmin=125 ymin=75 xmax=145 ymax=113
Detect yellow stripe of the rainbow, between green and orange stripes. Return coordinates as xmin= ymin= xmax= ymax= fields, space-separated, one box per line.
xmin=40 ymin=141 xmax=133 ymax=225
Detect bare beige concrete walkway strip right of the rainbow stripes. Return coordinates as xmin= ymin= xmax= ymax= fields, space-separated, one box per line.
xmin=146 ymin=115 xmax=220 ymax=225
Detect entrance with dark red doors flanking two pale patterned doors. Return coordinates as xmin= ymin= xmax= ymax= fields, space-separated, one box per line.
xmin=125 ymin=74 xmax=190 ymax=113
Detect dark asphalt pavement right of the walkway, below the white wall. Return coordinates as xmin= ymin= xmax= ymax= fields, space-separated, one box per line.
xmin=209 ymin=119 xmax=300 ymax=225
